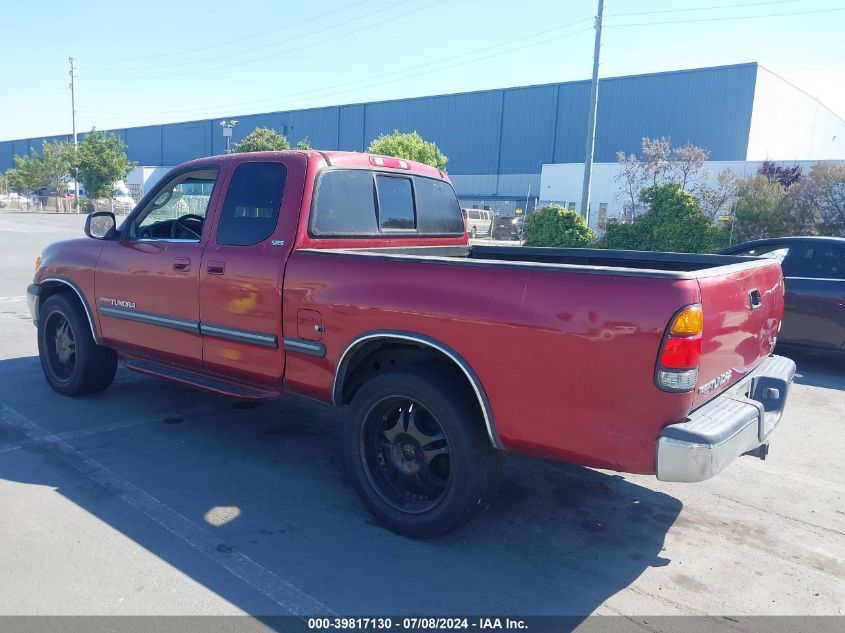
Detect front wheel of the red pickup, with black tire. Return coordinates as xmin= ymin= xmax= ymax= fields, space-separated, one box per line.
xmin=38 ymin=293 xmax=117 ymax=396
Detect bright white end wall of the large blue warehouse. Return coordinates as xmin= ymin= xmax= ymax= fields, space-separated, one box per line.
xmin=746 ymin=66 xmax=845 ymax=161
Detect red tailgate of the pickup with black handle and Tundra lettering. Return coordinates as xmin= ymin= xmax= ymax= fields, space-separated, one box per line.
xmin=693 ymin=260 xmax=783 ymax=408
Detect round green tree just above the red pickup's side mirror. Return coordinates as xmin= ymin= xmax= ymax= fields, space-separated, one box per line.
xmin=77 ymin=129 xmax=136 ymax=199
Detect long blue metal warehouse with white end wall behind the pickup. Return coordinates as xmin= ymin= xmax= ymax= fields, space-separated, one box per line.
xmin=0 ymin=63 xmax=845 ymax=210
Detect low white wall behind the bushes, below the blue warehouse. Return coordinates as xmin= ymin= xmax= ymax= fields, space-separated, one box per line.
xmin=538 ymin=160 xmax=845 ymax=229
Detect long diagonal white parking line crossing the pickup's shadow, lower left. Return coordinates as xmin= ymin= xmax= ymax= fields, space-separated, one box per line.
xmin=0 ymin=404 xmax=334 ymax=616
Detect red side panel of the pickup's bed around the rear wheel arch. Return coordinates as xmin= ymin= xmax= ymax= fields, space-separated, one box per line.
xmin=284 ymin=251 xmax=699 ymax=473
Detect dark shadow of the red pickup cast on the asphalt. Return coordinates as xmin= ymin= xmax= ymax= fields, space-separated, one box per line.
xmin=0 ymin=358 xmax=682 ymax=617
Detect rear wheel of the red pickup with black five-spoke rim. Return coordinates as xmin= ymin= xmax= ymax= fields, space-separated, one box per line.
xmin=344 ymin=364 xmax=503 ymax=538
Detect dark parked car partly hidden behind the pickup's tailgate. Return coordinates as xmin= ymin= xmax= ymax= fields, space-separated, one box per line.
xmin=722 ymin=237 xmax=845 ymax=352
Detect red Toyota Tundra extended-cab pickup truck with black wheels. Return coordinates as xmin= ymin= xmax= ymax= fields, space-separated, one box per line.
xmin=28 ymin=151 xmax=795 ymax=537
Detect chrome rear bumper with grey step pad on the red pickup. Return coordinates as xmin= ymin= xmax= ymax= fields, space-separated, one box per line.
xmin=656 ymin=356 xmax=795 ymax=482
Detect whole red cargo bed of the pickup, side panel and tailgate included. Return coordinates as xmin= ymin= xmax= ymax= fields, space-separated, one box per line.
xmin=284 ymin=246 xmax=782 ymax=473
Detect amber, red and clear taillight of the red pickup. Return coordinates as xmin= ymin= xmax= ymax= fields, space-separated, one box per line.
xmin=655 ymin=303 xmax=704 ymax=392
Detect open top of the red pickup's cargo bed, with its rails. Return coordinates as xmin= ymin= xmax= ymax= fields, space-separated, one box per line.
xmin=304 ymin=246 xmax=767 ymax=279
